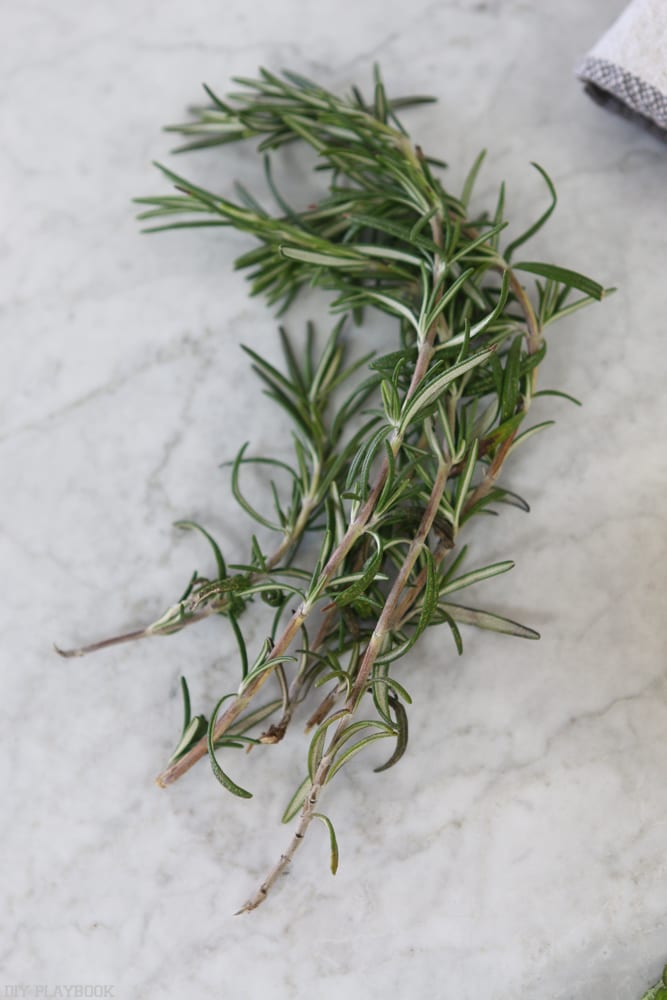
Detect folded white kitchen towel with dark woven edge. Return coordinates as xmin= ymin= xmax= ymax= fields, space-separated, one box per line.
xmin=576 ymin=0 xmax=667 ymax=137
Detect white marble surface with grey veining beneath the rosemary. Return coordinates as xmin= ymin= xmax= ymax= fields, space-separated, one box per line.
xmin=0 ymin=0 xmax=667 ymax=1000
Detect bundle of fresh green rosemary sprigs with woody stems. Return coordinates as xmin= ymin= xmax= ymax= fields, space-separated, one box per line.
xmin=60 ymin=70 xmax=604 ymax=910
